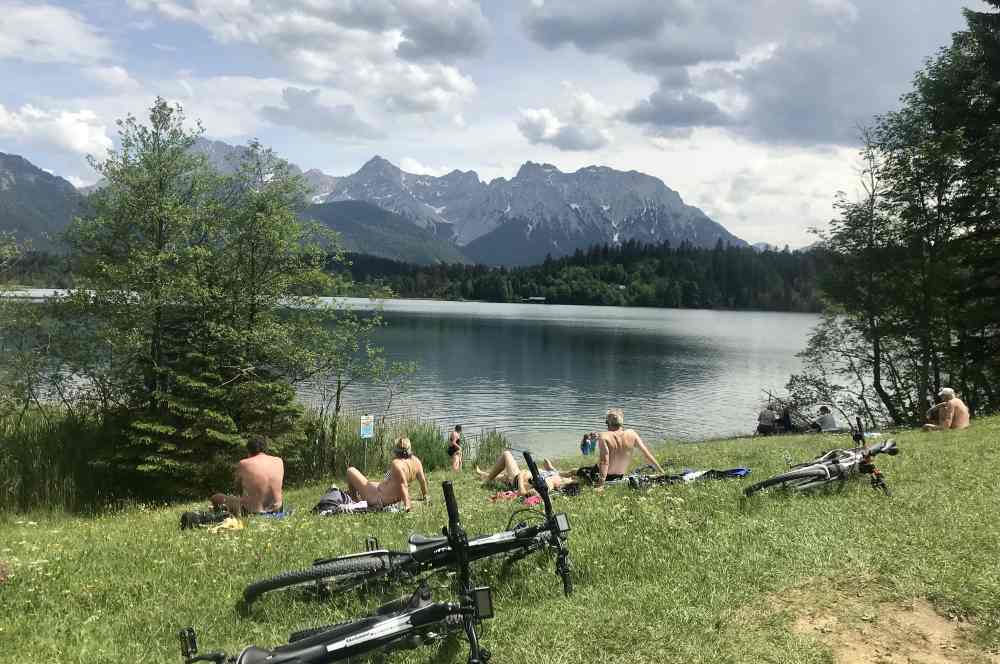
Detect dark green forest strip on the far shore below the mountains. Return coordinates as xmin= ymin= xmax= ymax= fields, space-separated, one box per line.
xmin=351 ymin=241 xmax=826 ymax=311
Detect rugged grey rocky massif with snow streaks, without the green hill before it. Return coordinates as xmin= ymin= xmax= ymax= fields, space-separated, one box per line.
xmin=324 ymin=157 xmax=747 ymax=265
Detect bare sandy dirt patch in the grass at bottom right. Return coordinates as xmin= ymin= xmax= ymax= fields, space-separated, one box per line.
xmin=775 ymin=590 xmax=1000 ymax=664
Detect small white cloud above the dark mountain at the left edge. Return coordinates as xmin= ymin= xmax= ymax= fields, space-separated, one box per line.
xmin=0 ymin=104 xmax=112 ymax=155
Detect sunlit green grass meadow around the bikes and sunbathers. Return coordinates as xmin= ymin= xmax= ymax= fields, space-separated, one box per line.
xmin=0 ymin=418 xmax=1000 ymax=664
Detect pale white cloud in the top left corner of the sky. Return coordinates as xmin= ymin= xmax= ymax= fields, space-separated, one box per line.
xmin=0 ymin=0 xmax=110 ymax=63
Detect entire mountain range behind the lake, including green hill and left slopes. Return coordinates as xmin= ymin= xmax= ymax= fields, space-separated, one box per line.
xmin=0 ymin=139 xmax=748 ymax=265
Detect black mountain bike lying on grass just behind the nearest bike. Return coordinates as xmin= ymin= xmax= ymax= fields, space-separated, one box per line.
xmin=242 ymin=452 xmax=573 ymax=610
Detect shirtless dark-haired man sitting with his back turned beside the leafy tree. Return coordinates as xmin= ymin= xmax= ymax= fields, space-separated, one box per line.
xmin=211 ymin=434 xmax=285 ymax=516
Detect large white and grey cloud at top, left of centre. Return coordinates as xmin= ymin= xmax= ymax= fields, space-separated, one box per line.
xmin=129 ymin=0 xmax=487 ymax=113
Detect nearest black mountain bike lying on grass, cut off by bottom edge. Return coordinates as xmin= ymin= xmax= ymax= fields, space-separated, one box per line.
xmin=180 ymin=482 xmax=493 ymax=664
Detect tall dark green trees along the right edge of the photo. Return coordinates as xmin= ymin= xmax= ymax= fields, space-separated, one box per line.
xmin=800 ymin=2 xmax=1000 ymax=424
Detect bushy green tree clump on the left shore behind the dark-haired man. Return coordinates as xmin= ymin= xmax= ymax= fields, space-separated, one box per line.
xmin=56 ymin=99 xmax=344 ymax=493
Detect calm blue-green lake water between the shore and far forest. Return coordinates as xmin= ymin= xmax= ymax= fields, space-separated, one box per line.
xmin=302 ymin=300 xmax=819 ymax=454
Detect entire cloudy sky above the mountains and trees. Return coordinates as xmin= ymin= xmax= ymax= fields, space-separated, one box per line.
xmin=0 ymin=0 xmax=985 ymax=247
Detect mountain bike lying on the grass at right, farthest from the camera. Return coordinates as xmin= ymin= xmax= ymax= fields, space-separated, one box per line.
xmin=743 ymin=417 xmax=899 ymax=497
